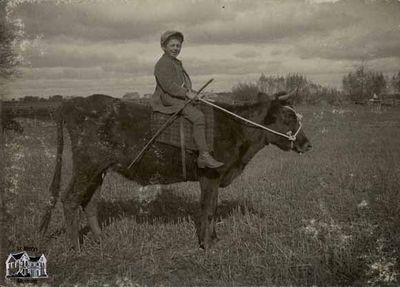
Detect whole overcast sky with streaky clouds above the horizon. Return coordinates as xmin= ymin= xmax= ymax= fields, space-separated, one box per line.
xmin=5 ymin=0 xmax=400 ymax=97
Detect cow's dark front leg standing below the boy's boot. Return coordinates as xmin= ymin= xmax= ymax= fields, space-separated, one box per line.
xmin=198 ymin=177 xmax=219 ymax=249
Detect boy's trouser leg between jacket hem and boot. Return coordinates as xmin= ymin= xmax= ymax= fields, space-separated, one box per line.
xmin=182 ymin=104 xmax=208 ymax=153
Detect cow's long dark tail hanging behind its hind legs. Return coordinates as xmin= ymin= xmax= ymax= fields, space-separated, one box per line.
xmin=40 ymin=109 xmax=64 ymax=234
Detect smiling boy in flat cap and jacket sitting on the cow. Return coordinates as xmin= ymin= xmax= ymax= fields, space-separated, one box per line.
xmin=151 ymin=31 xmax=223 ymax=171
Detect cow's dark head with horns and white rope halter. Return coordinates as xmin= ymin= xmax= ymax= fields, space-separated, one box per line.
xmin=263 ymin=90 xmax=312 ymax=153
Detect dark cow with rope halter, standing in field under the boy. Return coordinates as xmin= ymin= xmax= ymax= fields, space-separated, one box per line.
xmin=40 ymin=93 xmax=311 ymax=250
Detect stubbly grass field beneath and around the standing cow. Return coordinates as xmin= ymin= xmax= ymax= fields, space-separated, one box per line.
xmin=6 ymin=106 xmax=400 ymax=286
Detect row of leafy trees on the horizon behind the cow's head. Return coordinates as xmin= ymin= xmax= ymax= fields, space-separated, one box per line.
xmin=247 ymin=64 xmax=400 ymax=105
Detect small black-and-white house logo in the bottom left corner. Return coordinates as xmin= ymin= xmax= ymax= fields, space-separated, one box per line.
xmin=6 ymin=251 xmax=47 ymax=279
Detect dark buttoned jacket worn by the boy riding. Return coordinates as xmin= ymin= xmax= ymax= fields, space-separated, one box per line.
xmin=151 ymin=53 xmax=192 ymax=114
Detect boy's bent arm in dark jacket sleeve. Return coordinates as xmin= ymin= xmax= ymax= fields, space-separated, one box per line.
xmin=154 ymin=62 xmax=188 ymax=99
